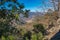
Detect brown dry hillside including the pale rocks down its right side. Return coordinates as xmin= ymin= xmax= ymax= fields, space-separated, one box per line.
xmin=18 ymin=12 xmax=60 ymax=39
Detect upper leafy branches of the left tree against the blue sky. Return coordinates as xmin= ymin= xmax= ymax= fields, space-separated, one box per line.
xmin=0 ymin=0 xmax=29 ymax=19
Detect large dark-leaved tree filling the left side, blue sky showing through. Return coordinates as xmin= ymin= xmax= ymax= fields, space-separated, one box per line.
xmin=0 ymin=0 xmax=29 ymax=37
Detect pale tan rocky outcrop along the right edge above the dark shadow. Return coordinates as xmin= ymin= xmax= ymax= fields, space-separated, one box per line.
xmin=45 ymin=18 xmax=60 ymax=40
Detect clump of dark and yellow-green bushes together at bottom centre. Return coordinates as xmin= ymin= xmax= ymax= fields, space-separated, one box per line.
xmin=21 ymin=24 xmax=45 ymax=40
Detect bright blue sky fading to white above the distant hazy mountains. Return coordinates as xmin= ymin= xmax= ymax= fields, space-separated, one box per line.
xmin=0 ymin=0 xmax=53 ymax=12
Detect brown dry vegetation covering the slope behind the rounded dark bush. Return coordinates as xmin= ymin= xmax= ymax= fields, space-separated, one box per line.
xmin=18 ymin=12 xmax=58 ymax=30
